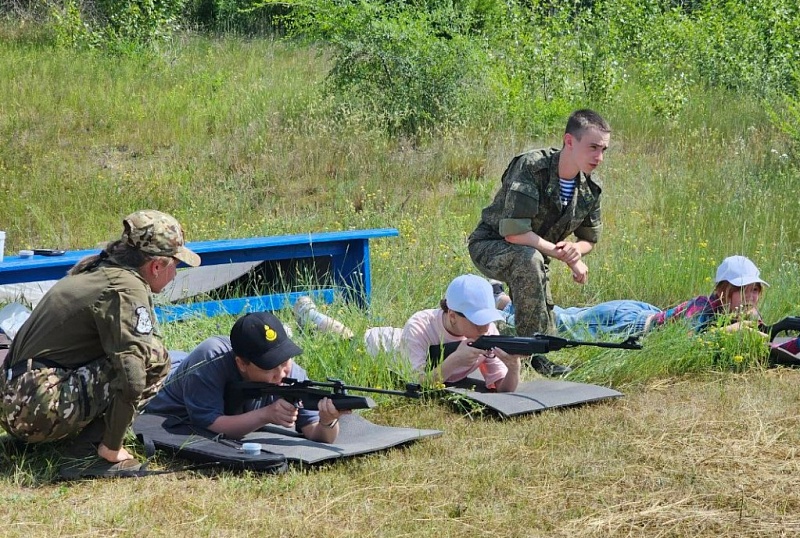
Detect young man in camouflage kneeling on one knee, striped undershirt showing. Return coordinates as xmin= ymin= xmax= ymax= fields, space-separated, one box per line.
xmin=469 ymin=109 xmax=611 ymax=372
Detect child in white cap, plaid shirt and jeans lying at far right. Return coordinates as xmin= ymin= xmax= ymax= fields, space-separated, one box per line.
xmin=497 ymin=256 xmax=769 ymax=339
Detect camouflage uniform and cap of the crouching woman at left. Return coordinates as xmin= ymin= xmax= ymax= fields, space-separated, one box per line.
xmin=0 ymin=210 xmax=200 ymax=450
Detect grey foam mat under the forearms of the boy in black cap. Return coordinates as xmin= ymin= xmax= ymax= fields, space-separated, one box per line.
xmin=242 ymin=414 xmax=443 ymax=463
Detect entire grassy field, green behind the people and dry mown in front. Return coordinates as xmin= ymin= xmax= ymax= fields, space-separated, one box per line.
xmin=0 ymin=23 xmax=800 ymax=537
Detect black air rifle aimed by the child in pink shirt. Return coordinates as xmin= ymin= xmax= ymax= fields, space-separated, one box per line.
xmin=429 ymin=334 xmax=642 ymax=366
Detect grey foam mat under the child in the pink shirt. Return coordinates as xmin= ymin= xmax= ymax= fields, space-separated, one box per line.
xmin=444 ymin=370 xmax=622 ymax=418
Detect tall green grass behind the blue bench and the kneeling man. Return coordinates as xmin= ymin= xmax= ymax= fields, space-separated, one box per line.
xmin=0 ymin=28 xmax=800 ymax=381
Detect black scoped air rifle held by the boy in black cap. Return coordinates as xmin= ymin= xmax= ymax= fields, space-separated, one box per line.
xmin=225 ymin=377 xmax=422 ymax=415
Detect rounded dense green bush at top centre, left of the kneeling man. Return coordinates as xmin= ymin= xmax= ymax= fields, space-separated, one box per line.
xmin=278 ymin=0 xmax=483 ymax=137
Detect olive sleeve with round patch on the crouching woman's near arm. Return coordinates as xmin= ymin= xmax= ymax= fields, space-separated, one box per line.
xmin=95 ymin=285 xmax=168 ymax=450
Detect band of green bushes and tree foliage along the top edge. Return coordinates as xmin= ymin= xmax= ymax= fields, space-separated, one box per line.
xmin=6 ymin=0 xmax=800 ymax=136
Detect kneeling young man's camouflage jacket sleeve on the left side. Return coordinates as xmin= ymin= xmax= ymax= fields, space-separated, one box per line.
xmin=499 ymin=156 xmax=540 ymax=237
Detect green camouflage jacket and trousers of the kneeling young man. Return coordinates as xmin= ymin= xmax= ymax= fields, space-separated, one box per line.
xmin=469 ymin=144 xmax=601 ymax=336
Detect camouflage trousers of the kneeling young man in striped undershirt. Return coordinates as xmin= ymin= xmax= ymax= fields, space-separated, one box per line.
xmin=469 ymin=239 xmax=556 ymax=336
